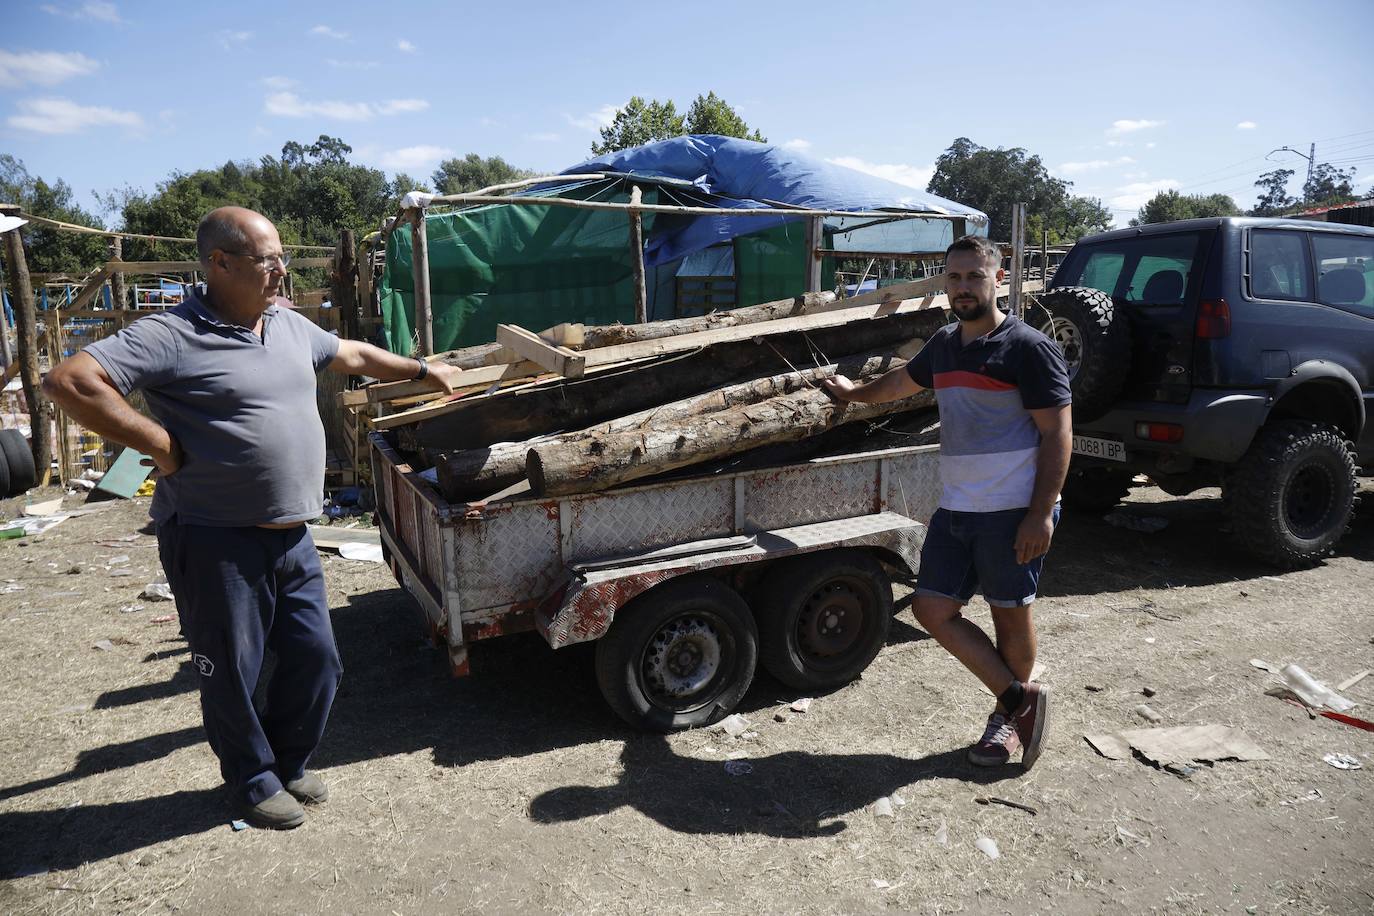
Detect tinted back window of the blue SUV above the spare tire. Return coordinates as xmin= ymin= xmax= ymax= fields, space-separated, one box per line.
xmin=1055 ymin=232 xmax=1201 ymax=305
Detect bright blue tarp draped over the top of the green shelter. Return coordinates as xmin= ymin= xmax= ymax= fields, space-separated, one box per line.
xmin=561 ymin=135 xmax=988 ymax=265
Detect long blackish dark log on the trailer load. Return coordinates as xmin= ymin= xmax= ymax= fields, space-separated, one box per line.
xmin=401 ymin=310 xmax=945 ymax=452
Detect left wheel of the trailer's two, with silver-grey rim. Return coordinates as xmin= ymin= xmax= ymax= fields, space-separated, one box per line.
xmin=596 ymin=575 xmax=758 ymax=732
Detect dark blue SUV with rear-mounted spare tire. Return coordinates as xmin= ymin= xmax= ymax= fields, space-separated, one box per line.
xmin=1026 ymin=217 xmax=1374 ymax=567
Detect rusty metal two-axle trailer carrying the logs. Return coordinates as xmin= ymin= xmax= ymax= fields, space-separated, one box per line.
xmin=370 ymin=431 xmax=940 ymax=731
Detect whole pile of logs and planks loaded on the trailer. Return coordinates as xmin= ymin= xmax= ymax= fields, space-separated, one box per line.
xmin=354 ymin=271 xmax=1038 ymax=503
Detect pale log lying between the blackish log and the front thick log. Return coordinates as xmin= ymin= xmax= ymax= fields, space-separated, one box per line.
xmin=434 ymin=353 xmax=903 ymax=501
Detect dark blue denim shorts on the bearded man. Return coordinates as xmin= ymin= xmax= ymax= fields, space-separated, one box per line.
xmin=916 ymin=505 xmax=1059 ymax=607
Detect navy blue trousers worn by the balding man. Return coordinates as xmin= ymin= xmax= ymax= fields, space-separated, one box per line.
xmin=158 ymin=518 xmax=344 ymax=805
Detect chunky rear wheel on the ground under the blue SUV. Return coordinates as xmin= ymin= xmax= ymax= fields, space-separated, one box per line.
xmin=1226 ymin=420 xmax=1356 ymax=569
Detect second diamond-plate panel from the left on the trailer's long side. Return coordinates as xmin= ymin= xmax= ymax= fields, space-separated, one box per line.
xmin=563 ymin=478 xmax=735 ymax=563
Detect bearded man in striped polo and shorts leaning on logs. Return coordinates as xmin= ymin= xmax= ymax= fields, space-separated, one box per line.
xmin=826 ymin=236 xmax=1072 ymax=769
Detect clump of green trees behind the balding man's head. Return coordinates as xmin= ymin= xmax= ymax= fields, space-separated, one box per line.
xmin=103 ymin=136 xmax=415 ymax=261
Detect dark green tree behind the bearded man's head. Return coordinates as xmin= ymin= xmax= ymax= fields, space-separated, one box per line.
xmin=926 ymin=137 xmax=1112 ymax=244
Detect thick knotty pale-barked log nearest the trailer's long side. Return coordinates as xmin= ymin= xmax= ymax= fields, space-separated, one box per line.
xmin=525 ymin=389 xmax=934 ymax=497
